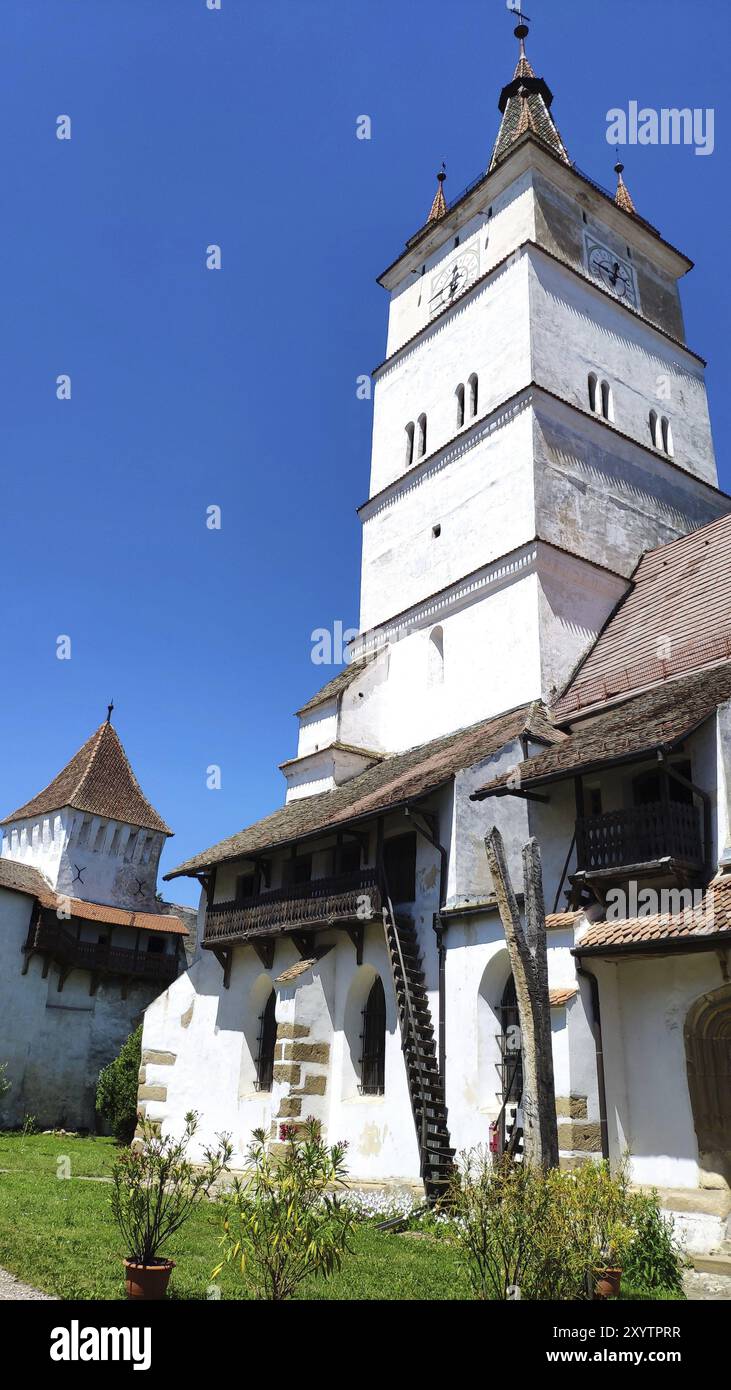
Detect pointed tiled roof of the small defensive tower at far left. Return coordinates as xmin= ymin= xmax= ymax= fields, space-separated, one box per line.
xmin=0 ymin=723 xmax=172 ymax=835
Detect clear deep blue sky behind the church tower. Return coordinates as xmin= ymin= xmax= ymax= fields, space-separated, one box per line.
xmin=0 ymin=0 xmax=731 ymax=901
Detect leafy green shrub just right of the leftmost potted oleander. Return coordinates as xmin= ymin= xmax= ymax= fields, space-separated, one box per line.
xmin=213 ymin=1120 xmax=357 ymax=1301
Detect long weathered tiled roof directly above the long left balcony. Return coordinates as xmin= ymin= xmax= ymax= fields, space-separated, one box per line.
xmin=165 ymin=703 xmax=563 ymax=878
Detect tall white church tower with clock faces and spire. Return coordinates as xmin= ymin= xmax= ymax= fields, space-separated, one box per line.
xmin=284 ymin=22 xmax=730 ymax=778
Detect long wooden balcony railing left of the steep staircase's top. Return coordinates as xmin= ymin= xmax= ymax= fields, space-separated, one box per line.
xmin=203 ymin=869 xmax=381 ymax=947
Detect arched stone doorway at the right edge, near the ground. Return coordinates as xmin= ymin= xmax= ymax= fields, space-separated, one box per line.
xmin=685 ymin=984 xmax=731 ymax=1187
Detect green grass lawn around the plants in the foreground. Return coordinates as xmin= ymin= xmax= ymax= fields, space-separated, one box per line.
xmin=0 ymin=1133 xmax=689 ymax=1301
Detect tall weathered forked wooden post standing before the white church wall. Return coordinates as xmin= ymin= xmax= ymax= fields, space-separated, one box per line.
xmin=485 ymin=826 xmax=559 ymax=1168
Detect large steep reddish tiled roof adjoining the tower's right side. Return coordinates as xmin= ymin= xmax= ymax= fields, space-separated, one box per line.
xmin=553 ymin=513 xmax=731 ymax=720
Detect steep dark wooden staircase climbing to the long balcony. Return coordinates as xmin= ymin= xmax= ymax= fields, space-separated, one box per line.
xmin=384 ymin=897 xmax=454 ymax=1202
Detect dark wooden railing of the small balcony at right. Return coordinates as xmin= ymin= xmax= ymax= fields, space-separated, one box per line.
xmin=577 ymin=801 xmax=703 ymax=872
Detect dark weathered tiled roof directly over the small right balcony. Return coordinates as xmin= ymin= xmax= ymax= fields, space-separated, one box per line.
xmin=474 ymin=662 xmax=731 ymax=801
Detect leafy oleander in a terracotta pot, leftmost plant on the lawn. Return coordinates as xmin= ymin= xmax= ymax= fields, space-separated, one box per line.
xmin=111 ymin=1111 xmax=233 ymax=1300
